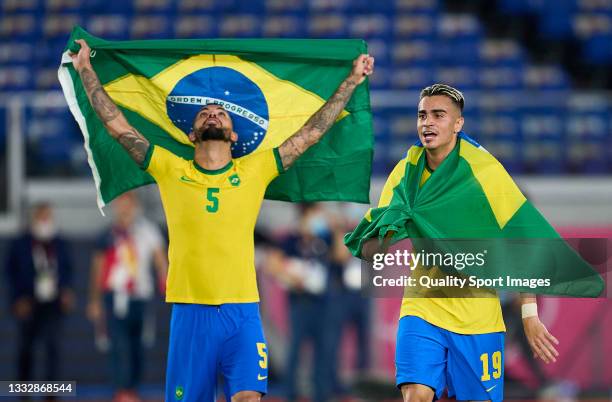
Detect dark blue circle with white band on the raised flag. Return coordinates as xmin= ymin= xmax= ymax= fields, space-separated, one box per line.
xmin=166 ymin=67 xmax=269 ymax=158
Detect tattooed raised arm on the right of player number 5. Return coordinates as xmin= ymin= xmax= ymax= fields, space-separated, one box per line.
xmin=278 ymin=54 xmax=374 ymax=169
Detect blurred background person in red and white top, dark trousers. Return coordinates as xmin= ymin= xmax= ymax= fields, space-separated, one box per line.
xmin=88 ymin=193 xmax=168 ymax=402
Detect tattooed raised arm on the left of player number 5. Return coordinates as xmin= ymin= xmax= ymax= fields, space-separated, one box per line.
xmin=71 ymin=39 xmax=150 ymax=165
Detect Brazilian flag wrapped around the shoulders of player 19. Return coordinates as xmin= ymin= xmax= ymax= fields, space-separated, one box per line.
xmin=344 ymin=132 xmax=604 ymax=297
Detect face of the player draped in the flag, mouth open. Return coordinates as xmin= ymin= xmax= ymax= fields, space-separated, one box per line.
xmin=417 ymin=95 xmax=463 ymax=151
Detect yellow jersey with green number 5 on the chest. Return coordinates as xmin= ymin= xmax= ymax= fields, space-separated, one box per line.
xmin=143 ymin=145 xmax=283 ymax=305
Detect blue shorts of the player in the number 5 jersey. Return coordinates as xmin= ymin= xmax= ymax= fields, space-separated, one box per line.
xmin=166 ymin=303 xmax=268 ymax=402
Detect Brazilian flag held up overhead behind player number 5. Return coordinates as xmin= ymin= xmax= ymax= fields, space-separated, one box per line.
xmin=59 ymin=27 xmax=373 ymax=208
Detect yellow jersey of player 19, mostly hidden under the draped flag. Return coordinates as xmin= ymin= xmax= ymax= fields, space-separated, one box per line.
xmin=378 ymin=158 xmax=506 ymax=334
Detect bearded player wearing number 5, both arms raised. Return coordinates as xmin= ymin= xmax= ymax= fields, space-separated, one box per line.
xmin=72 ymin=40 xmax=374 ymax=402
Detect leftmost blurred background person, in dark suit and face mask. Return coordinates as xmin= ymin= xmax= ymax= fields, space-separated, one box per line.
xmin=6 ymin=202 xmax=74 ymax=400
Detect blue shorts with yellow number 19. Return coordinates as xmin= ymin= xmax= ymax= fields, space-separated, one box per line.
xmin=395 ymin=316 xmax=504 ymax=402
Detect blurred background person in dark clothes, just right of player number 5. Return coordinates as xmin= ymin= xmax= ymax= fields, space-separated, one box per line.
xmin=268 ymin=204 xmax=343 ymax=402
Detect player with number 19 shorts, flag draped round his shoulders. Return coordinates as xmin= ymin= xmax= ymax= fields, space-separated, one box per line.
xmin=362 ymin=84 xmax=558 ymax=402
